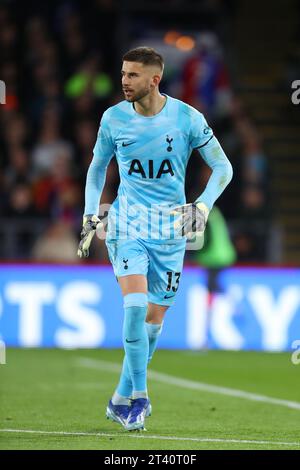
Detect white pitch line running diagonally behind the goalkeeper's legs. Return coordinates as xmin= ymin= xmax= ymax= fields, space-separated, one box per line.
xmin=78 ymin=357 xmax=300 ymax=410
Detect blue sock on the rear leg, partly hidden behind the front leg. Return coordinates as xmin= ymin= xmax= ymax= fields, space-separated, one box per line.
xmin=117 ymin=323 xmax=163 ymax=397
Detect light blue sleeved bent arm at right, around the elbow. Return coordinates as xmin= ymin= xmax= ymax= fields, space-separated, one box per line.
xmin=197 ymin=137 xmax=233 ymax=209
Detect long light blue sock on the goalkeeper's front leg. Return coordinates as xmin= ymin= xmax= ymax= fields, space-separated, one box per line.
xmin=117 ymin=293 xmax=149 ymax=397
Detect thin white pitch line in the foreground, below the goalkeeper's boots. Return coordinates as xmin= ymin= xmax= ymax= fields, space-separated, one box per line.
xmin=0 ymin=429 xmax=300 ymax=447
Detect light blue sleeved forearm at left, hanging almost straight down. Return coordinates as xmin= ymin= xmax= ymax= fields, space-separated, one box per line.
xmin=84 ymin=157 xmax=107 ymax=215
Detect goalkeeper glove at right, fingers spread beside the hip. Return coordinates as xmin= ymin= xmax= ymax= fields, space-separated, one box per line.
xmin=171 ymin=202 xmax=209 ymax=238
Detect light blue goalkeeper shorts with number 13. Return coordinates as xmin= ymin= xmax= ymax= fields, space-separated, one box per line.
xmin=106 ymin=239 xmax=186 ymax=306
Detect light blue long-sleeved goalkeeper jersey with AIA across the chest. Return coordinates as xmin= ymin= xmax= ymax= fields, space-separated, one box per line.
xmin=84 ymin=96 xmax=232 ymax=243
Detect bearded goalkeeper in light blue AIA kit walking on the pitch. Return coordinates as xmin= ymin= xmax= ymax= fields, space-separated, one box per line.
xmin=78 ymin=47 xmax=232 ymax=431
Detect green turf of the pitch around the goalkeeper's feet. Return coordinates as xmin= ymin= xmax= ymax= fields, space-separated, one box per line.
xmin=0 ymin=349 xmax=300 ymax=450
